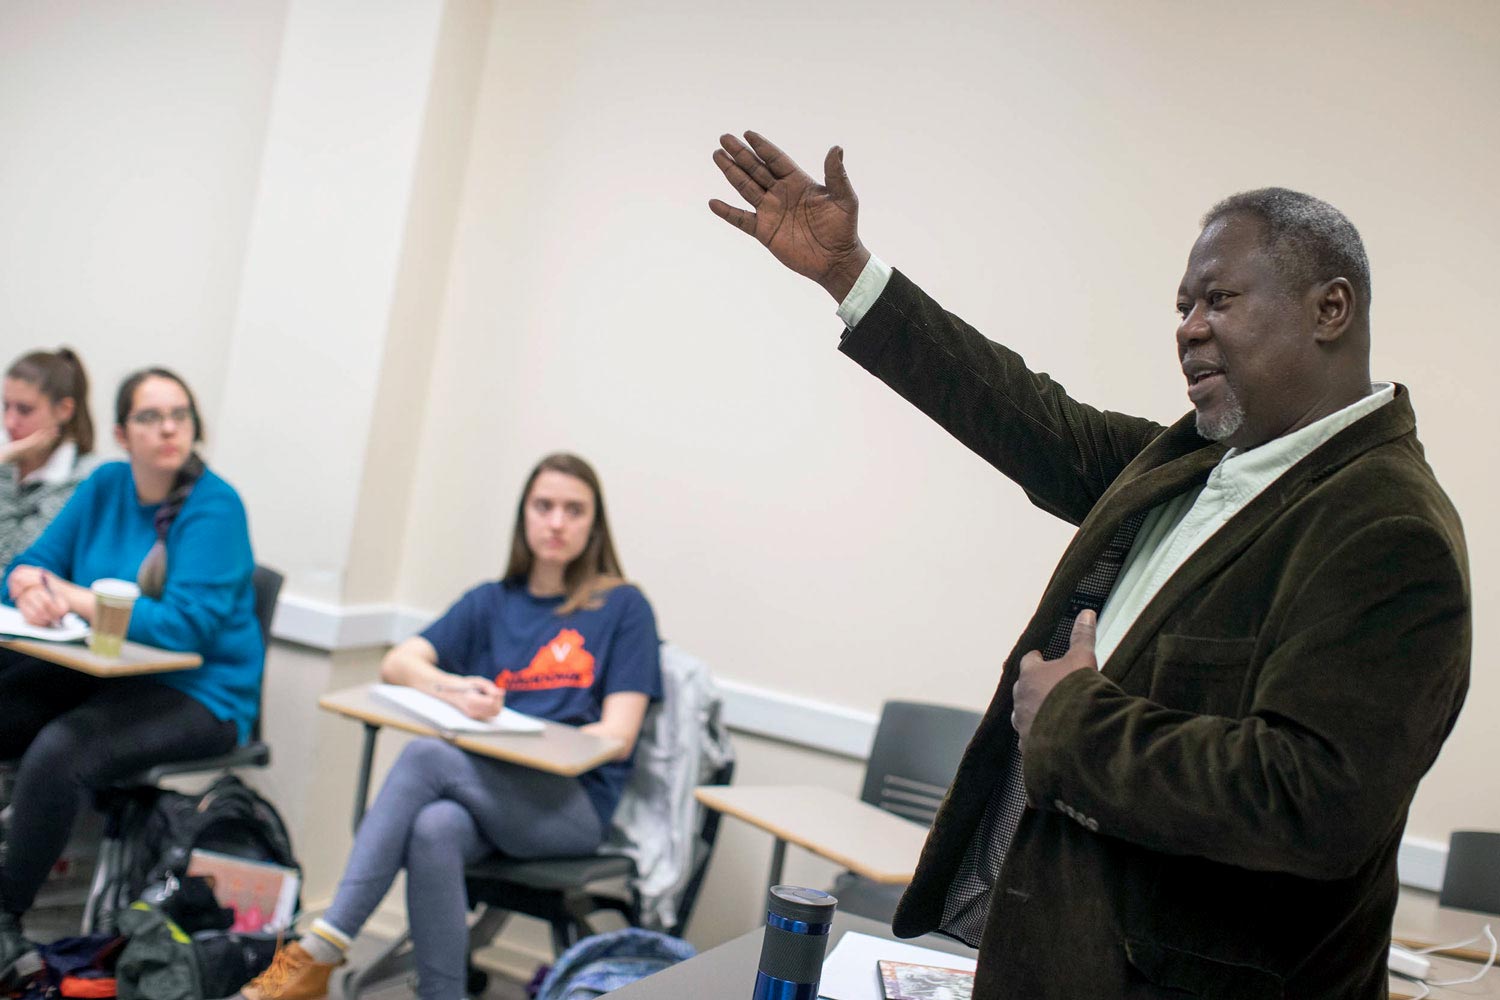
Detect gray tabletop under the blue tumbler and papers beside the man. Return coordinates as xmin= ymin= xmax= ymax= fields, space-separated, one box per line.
xmin=606 ymin=913 xmax=975 ymax=1000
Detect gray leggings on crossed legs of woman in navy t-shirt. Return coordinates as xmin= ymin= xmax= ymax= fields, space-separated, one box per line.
xmin=323 ymin=739 xmax=605 ymax=1000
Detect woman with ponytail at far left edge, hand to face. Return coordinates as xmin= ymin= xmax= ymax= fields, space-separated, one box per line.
xmin=0 ymin=348 xmax=95 ymax=567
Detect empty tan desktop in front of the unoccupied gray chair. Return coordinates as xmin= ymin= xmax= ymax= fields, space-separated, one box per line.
xmin=695 ymin=784 xmax=927 ymax=885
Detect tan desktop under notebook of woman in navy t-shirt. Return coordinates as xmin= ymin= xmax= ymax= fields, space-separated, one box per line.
xmin=318 ymin=684 xmax=620 ymax=777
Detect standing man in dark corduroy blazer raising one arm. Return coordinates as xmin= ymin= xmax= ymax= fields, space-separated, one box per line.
xmin=710 ymin=132 xmax=1470 ymax=1000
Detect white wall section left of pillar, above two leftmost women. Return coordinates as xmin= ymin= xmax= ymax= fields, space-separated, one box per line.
xmin=0 ymin=0 xmax=285 ymax=454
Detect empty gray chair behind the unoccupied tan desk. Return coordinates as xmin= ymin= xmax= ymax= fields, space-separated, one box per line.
xmin=830 ymin=702 xmax=980 ymax=924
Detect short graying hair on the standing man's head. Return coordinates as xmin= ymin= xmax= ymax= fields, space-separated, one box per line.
xmin=1202 ymin=187 xmax=1370 ymax=315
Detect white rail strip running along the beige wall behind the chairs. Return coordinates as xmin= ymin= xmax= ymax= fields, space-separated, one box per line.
xmin=272 ymin=594 xmax=1448 ymax=893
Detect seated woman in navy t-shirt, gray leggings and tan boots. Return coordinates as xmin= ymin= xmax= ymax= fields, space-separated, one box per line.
xmin=239 ymin=454 xmax=662 ymax=1000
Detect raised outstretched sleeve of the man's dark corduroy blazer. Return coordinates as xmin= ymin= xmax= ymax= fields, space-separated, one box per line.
xmin=839 ymin=271 xmax=1163 ymax=525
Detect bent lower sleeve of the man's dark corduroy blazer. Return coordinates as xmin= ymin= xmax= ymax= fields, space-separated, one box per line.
xmin=1025 ymin=516 xmax=1470 ymax=879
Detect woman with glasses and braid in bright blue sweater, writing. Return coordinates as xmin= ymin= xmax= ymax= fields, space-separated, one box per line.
xmin=0 ymin=369 xmax=266 ymax=993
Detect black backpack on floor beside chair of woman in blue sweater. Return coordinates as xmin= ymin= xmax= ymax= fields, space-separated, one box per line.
xmin=101 ymin=774 xmax=302 ymax=929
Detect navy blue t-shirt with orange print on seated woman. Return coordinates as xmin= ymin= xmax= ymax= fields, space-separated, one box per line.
xmin=422 ymin=580 xmax=662 ymax=828
